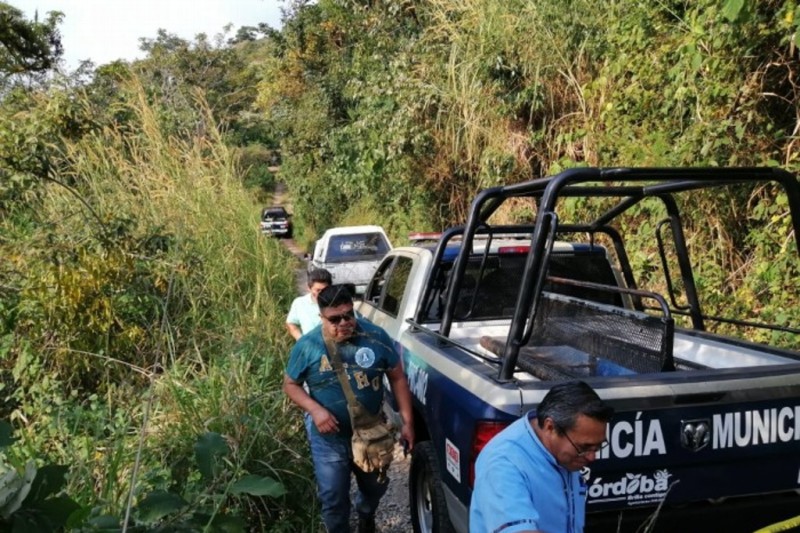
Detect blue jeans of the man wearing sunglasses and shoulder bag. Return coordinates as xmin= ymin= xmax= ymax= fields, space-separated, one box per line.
xmin=305 ymin=413 xmax=389 ymax=533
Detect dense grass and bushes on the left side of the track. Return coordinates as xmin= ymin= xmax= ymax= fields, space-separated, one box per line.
xmin=0 ymin=4 xmax=316 ymax=531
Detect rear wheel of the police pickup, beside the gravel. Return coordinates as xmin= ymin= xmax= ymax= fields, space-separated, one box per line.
xmin=408 ymin=441 xmax=455 ymax=533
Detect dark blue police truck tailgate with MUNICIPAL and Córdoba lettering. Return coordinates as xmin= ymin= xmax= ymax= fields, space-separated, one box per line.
xmin=586 ymin=380 xmax=800 ymax=512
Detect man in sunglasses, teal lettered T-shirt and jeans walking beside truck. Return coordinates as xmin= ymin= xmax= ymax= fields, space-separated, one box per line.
xmin=283 ymin=285 xmax=414 ymax=533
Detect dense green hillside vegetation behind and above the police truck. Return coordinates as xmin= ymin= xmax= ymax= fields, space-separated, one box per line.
xmin=258 ymin=0 xmax=800 ymax=346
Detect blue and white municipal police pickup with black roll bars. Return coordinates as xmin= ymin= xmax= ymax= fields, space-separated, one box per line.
xmin=358 ymin=168 xmax=800 ymax=533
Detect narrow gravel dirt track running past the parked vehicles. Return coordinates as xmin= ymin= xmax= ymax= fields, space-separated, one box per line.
xmin=272 ymin=182 xmax=412 ymax=533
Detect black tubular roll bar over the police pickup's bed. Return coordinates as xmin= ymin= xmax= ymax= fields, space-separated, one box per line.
xmin=432 ymin=167 xmax=800 ymax=380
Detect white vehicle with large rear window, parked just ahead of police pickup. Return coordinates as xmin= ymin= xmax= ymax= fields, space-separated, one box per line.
xmin=308 ymin=226 xmax=392 ymax=294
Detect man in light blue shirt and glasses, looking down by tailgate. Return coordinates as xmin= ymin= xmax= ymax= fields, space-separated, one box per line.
xmin=469 ymin=381 xmax=614 ymax=533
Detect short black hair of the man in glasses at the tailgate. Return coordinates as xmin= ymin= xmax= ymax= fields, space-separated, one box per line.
xmin=536 ymin=381 xmax=614 ymax=432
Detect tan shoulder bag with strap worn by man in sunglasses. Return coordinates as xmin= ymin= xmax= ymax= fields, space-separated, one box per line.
xmin=325 ymin=340 xmax=397 ymax=481
